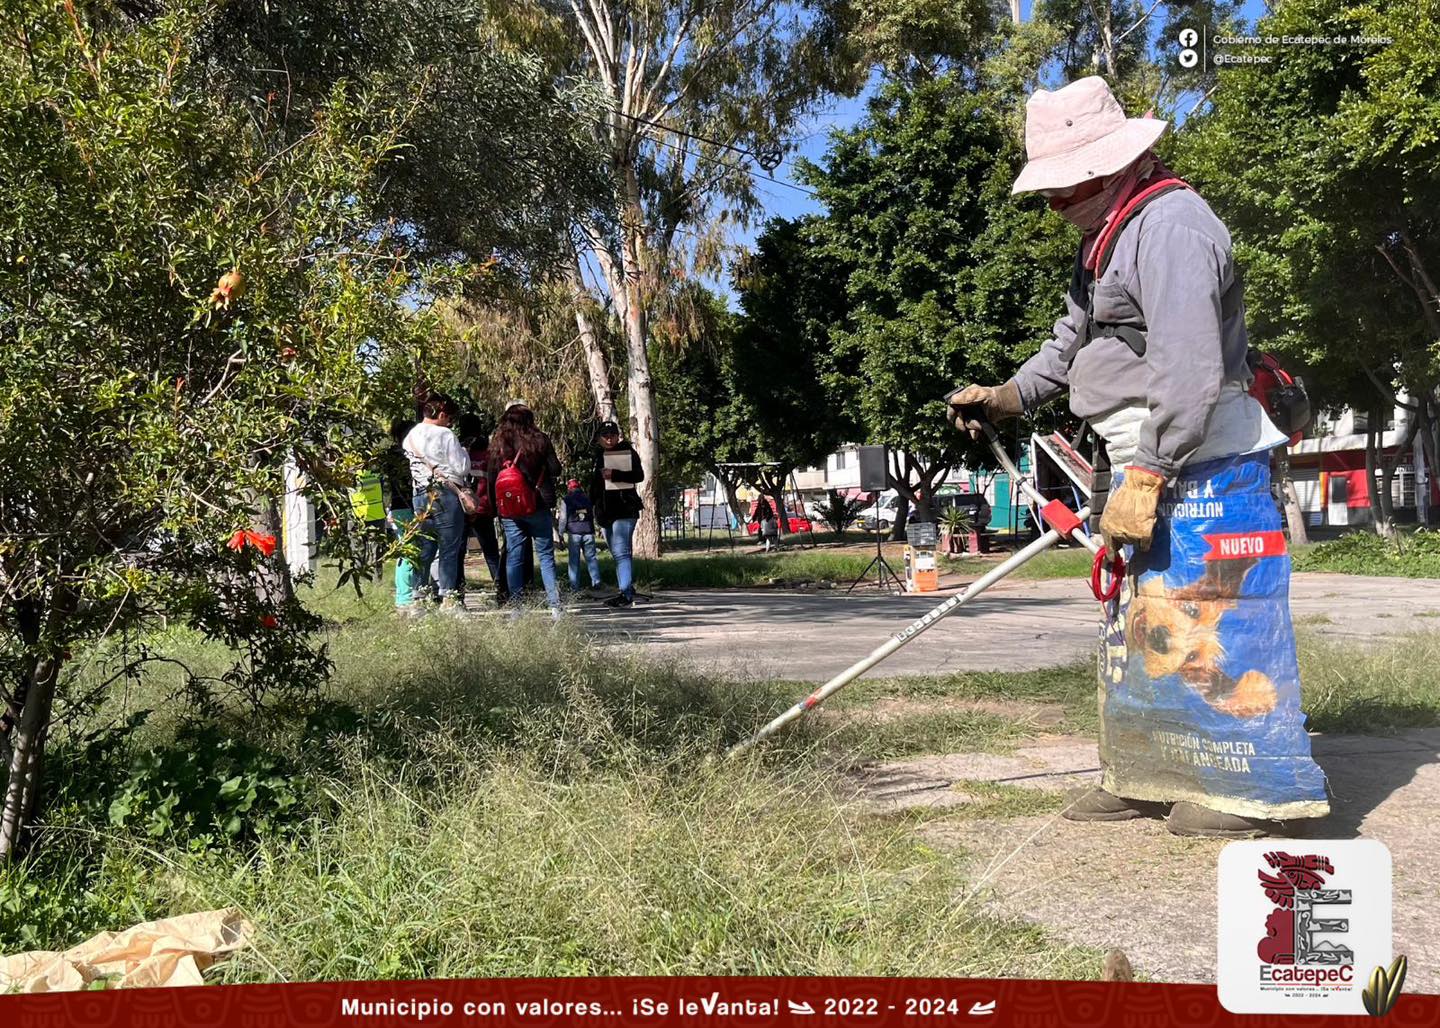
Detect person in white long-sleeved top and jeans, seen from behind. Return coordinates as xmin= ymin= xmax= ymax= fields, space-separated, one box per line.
xmin=405 ymin=392 xmax=469 ymax=606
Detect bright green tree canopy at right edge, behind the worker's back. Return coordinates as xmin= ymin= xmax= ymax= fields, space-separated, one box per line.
xmin=1176 ymin=0 xmax=1440 ymax=489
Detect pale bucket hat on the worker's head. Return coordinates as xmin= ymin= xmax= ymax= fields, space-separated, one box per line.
xmin=1009 ymin=75 xmax=1169 ymax=193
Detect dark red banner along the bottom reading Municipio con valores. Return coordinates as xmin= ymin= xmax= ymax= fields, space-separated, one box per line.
xmin=0 ymin=978 xmax=1440 ymax=1028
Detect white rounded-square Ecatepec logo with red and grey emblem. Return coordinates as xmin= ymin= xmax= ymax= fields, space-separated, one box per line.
xmin=1217 ymin=839 xmax=1391 ymax=1014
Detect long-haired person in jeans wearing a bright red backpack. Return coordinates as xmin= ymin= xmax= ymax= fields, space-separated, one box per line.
xmin=487 ymin=400 xmax=560 ymax=618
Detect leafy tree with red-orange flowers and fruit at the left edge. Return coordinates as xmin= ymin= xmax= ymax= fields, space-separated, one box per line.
xmin=0 ymin=0 xmax=446 ymax=855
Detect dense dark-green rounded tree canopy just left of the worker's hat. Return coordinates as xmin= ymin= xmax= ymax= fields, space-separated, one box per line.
xmin=805 ymin=75 xmax=1076 ymax=515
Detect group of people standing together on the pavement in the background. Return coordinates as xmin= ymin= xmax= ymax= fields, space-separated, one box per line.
xmin=383 ymin=392 xmax=645 ymax=618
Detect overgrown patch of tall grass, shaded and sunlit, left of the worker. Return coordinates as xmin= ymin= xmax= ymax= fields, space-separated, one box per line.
xmin=0 ymin=600 xmax=1097 ymax=980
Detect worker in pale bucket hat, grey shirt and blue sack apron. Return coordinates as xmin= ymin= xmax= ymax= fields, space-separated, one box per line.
xmin=946 ymin=76 xmax=1329 ymax=838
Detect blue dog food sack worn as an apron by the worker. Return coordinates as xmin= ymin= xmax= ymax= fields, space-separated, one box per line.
xmin=1099 ymin=454 xmax=1329 ymax=819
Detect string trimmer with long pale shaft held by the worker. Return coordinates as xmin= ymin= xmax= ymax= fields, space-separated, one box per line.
xmin=727 ymin=422 xmax=1125 ymax=756
